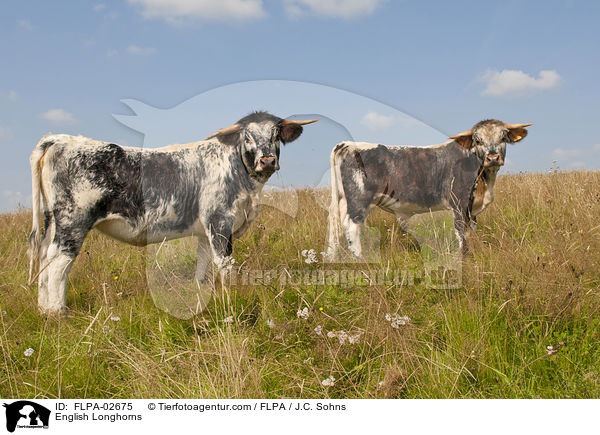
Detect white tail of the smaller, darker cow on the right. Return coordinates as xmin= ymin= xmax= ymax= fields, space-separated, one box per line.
xmin=327 ymin=142 xmax=347 ymax=261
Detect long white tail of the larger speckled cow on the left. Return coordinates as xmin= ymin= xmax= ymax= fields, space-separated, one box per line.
xmin=28 ymin=139 xmax=51 ymax=285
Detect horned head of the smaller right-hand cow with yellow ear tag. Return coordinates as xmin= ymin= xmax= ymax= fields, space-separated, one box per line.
xmin=450 ymin=119 xmax=532 ymax=169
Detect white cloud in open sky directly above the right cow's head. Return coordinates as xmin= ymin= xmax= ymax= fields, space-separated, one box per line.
xmin=480 ymin=69 xmax=563 ymax=97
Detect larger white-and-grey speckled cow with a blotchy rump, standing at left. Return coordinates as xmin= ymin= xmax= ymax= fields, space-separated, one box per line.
xmin=29 ymin=112 xmax=317 ymax=313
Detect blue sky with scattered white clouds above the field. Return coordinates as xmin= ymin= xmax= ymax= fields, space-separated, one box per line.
xmin=0 ymin=0 xmax=600 ymax=211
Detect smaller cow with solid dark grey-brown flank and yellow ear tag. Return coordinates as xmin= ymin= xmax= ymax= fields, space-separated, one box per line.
xmin=327 ymin=120 xmax=532 ymax=260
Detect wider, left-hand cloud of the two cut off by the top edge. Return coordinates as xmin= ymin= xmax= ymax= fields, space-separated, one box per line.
xmin=128 ymin=0 xmax=266 ymax=24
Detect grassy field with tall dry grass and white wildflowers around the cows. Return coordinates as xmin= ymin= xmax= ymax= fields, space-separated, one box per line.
xmin=0 ymin=172 xmax=600 ymax=398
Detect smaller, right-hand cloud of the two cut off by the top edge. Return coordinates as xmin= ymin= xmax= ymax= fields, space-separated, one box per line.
xmin=286 ymin=0 xmax=387 ymax=18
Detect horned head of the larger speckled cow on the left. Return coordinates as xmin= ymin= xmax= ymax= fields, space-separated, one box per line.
xmin=206 ymin=112 xmax=318 ymax=183
